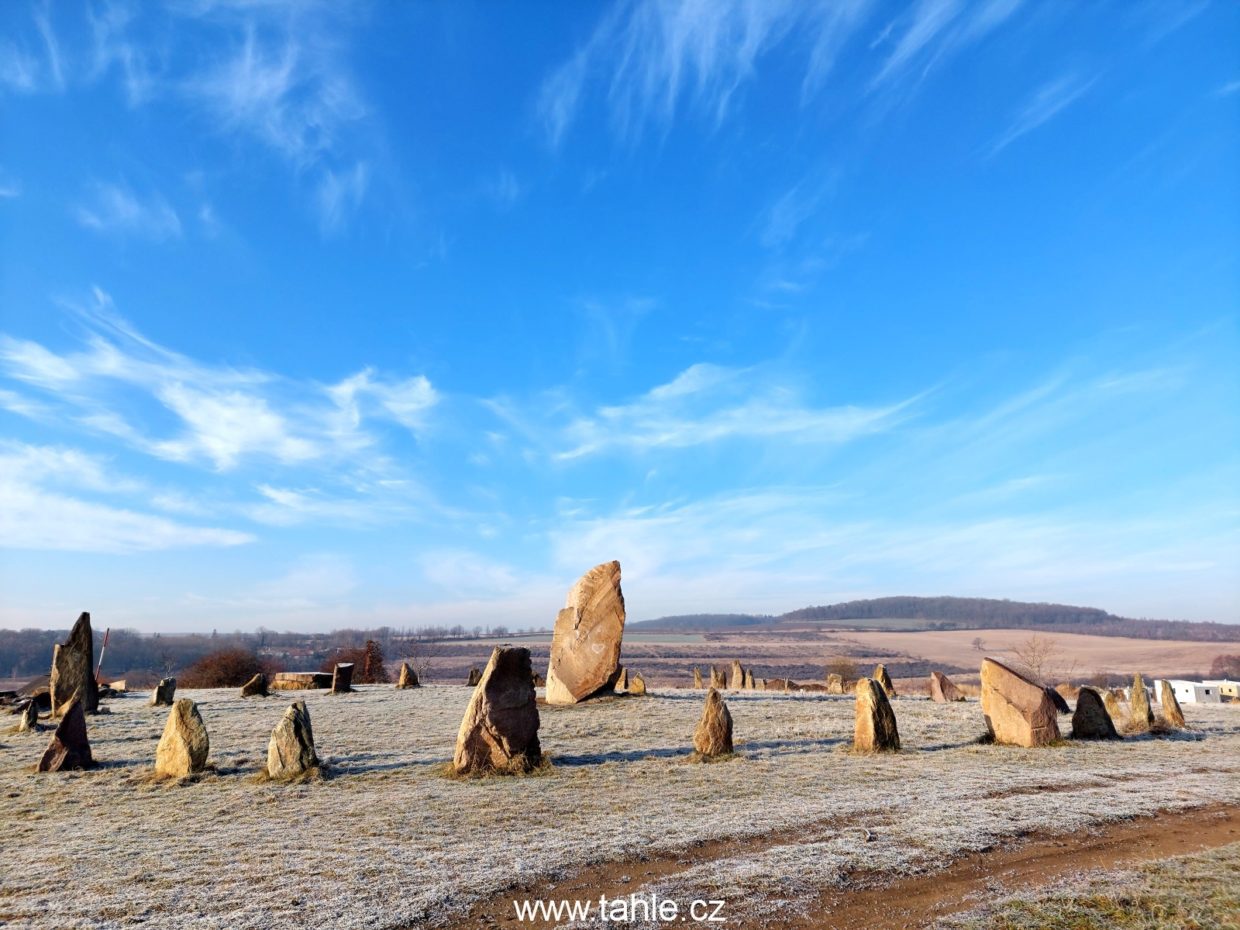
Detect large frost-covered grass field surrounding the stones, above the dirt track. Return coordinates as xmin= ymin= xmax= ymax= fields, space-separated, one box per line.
xmin=0 ymin=686 xmax=1240 ymax=930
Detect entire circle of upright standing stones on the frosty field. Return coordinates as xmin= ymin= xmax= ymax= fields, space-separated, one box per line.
xmin=17 ymin=562 xmax=1187 ymax=781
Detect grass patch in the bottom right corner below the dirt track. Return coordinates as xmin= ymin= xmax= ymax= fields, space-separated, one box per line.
xmin=936 ymin=843 xmax=1240 ymax=930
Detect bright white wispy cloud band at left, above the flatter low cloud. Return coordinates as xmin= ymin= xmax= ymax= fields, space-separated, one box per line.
xmin=0 ymin=289 xmax=439 ymax=472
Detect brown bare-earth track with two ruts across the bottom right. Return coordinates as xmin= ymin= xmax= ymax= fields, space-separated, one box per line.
xmin=429 ymin=805 xmax=1240 ymax=930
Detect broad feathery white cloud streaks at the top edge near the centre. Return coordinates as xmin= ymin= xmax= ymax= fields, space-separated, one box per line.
xmin=537 ymin=0 xmax=869 ymax=146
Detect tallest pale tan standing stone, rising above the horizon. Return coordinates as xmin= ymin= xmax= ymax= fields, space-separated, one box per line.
xmin=547 ymin=562 xmax=625 ymax=704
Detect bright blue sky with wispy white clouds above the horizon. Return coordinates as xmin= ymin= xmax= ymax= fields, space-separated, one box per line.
xmin=0 ymin=0 xmax=1240 ymax=630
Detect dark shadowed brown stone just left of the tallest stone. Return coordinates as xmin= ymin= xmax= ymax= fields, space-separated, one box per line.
xmin=453 ymin=646 xmax=542 ymax=774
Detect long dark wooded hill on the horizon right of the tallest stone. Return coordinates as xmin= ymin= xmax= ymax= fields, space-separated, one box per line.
xmin=644 ymin=596 xmax=1240 ymax=642
